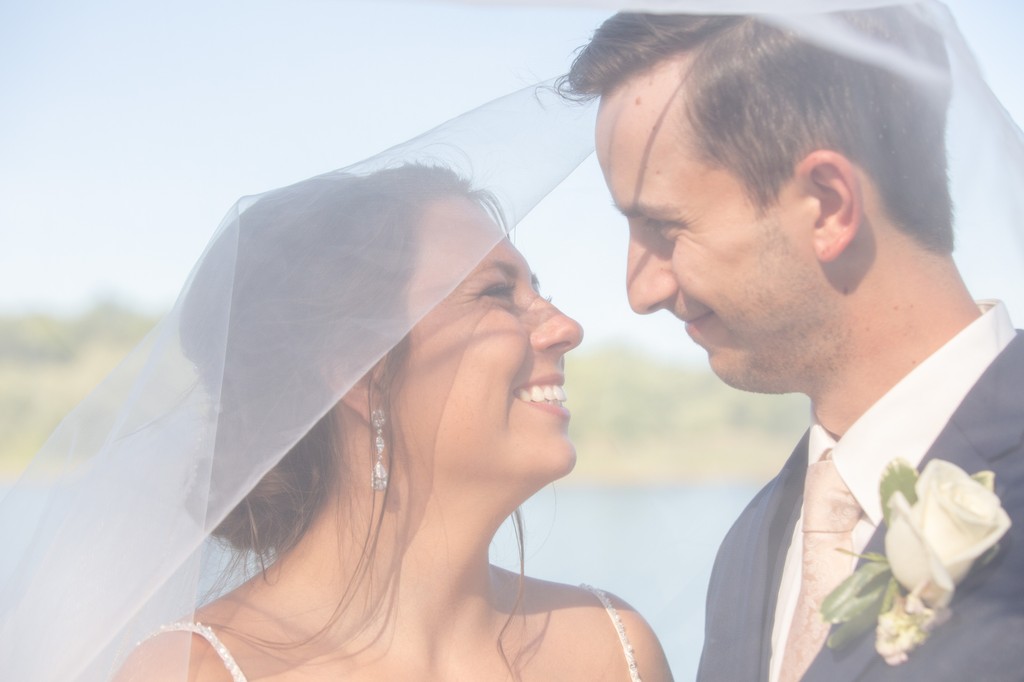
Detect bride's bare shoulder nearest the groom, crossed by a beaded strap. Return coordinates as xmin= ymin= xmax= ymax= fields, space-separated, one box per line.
xmin=522 ymin=578 xmax=672 ymax=682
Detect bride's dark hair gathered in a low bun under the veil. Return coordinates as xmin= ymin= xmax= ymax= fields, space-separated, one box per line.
xmin=181 ymin=165 xmax=499 ymax=567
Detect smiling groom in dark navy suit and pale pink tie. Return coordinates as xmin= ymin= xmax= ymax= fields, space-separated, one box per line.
xmin=563 ymin=8 xmax=1024 ymax=682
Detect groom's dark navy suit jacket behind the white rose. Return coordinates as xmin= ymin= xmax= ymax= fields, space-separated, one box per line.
xmin=697 ymin=332 xmax=1024 ymax=682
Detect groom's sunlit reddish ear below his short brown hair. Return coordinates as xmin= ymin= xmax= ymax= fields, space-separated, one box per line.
xmin=794 ymin=150 xmax=864 ymax=263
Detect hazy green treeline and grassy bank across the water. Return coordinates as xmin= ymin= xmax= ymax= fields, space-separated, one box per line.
xmin=0 ymin=304 xmax=808 ymax=483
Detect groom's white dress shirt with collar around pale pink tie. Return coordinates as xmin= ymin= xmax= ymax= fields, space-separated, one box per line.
xmin=768 ymin=301 xmax=1016 ymax=682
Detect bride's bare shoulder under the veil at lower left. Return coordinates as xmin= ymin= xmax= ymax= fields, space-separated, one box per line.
xmin=114 ymin=631 xmax=232 ymax=682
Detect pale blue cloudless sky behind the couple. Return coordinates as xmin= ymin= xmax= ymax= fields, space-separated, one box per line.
xmin=0 ymin=0 xmax=1024 ymax=359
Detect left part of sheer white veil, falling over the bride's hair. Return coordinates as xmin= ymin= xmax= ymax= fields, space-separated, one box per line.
xmin=2 ymin=84 xmax=592 ymax=680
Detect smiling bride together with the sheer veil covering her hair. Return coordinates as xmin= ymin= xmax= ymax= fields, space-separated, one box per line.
xmin=0 ymin=69 xmax=671 ymax=682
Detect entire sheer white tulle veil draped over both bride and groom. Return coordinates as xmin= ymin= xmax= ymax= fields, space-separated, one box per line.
xmin=0 ymin=0 xmax=1024 ymax=681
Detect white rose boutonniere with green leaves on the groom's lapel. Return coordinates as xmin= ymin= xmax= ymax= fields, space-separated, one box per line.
xmin=821 ymin=460 xmax=1010 ymax=666
